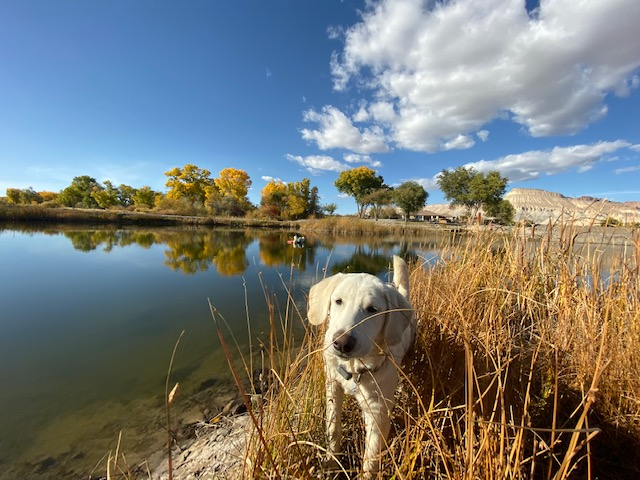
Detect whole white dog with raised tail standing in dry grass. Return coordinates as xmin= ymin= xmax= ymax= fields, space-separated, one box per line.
xmin=307 ymin=256 xmax=415 ymax=477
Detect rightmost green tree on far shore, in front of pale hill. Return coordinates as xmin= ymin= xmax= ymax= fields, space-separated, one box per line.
xmin=438 ymin=167 xmax=509 ymax=223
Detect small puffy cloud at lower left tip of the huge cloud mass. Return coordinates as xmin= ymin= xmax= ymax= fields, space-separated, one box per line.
xmin=301 ymin=105 xmax=389 ymax=153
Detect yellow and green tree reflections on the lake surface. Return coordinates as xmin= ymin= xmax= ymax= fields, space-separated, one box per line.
xmin=56 ymin=228 xmax=431 ymax=276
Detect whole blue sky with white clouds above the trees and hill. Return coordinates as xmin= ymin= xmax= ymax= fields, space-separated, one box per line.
xmin=0 ymin=0 xmax=640 ymax=214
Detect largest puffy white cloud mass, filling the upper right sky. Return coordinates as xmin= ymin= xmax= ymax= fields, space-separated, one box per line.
xmin=302 ymin=0 xmax=640 ymax=154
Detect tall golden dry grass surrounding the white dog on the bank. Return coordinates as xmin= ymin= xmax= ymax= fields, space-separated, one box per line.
xmin=234 ymin=221 xmax=640 ymax=479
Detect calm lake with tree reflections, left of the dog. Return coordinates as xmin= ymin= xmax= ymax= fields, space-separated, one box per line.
xmin=0 ymin=226 xmax=442 ymax=479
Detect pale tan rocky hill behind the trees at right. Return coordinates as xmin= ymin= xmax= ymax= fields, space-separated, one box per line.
xmin=426 ymin=188 xmax=640 ymax=225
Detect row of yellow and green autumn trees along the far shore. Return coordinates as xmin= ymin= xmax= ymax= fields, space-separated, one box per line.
xmin=6 ymin=164 xmax=513 ymax=221
